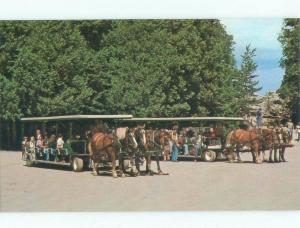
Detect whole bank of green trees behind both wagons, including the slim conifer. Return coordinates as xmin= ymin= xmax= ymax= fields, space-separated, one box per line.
xmin=0 ymin=20 xmax=257 ymax=119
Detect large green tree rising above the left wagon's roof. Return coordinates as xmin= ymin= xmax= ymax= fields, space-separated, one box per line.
xmin=6 ymin=22 xmax=106 ymax=116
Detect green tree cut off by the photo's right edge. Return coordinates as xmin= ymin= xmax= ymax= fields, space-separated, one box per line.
xmin=278 ymin=19 xmax=300 ymax=121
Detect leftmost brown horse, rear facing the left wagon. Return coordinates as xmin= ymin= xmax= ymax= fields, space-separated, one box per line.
xmin=88 ymin=128 xmax=118 ymax=178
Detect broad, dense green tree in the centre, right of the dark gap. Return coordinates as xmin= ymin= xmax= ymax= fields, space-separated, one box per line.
xmin=102 ymin=20 xmax=239 ymax=116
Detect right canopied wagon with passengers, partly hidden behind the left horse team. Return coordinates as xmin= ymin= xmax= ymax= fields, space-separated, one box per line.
xmin=120 ymin=117 xmax=245 ymax=162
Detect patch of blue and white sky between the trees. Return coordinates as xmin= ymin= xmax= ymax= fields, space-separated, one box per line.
xmin=221 ymin=18 xmax=284 ymax=95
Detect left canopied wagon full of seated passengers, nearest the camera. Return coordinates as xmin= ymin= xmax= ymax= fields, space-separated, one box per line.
xmin=21 ymin=115 xmax=132 ymax=172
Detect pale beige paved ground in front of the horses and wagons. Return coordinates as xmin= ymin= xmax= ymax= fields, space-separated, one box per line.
xmin=0 ymin=139 xmax=300 ymax=211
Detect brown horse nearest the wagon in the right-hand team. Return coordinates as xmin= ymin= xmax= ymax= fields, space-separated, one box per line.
xmin=226 ymin=128 xmax=262 ymax=163
